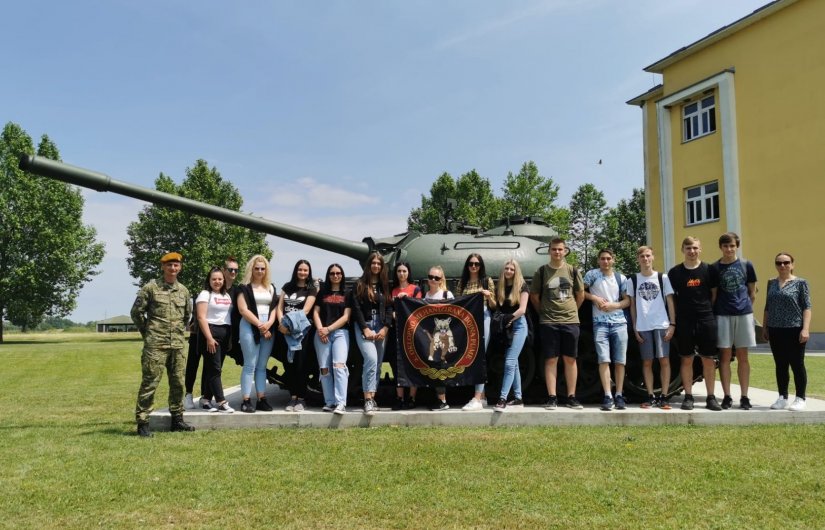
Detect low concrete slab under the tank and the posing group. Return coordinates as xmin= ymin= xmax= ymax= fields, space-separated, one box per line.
xmin=149 ymin=382 xmax=825 ymax=431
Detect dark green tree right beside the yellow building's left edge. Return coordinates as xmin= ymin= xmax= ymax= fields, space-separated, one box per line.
xmin=598 ymin=188 xmax=647 ymax=274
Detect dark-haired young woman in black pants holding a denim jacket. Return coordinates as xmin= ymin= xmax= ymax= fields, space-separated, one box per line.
xmin=276 ymin=259 xmax=318 ymax=412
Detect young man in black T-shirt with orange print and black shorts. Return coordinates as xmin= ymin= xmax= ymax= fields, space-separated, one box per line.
xmin=667 ymin=236 xmax=722 ymax=410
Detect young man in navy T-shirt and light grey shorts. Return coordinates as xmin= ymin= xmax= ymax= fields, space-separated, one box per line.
xmin=713 ymin=232 xmax=756 ymax=410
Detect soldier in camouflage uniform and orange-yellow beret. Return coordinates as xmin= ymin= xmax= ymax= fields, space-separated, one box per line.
xmin=132 ymin=252 xmax=195 ymax=437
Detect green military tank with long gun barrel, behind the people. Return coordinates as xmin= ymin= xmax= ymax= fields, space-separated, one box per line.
xmin=20 ymin=155 xmax=701 ymax=402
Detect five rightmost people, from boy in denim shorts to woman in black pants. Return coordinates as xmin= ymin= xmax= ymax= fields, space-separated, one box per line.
xmin=580 ymin=232 xmax=811 ymax=411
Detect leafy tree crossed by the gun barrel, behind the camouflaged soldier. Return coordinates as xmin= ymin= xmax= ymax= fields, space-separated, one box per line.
xmin=126 ymin=160 xmax=272 ymax=292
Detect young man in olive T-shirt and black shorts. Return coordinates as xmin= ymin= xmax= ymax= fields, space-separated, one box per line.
xmin=530 ymin=238 xmax=584 ymax=410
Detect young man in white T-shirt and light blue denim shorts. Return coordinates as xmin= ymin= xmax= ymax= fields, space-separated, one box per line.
xmin=584 ymin=248 xmax=630 ymax=410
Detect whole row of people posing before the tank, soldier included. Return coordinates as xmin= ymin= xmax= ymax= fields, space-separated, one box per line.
xmin=132 ymin=233 xmax=811 ymax=436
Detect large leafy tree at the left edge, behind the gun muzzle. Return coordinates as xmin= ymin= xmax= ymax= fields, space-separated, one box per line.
xmin=0 ymin=123 xmax=104 ymax=342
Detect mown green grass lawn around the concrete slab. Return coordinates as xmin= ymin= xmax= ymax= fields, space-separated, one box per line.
xmin=0 ymin=334 xmax=825 ymax=528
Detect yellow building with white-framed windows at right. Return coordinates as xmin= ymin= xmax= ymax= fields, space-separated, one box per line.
xmin=628 ymin=0 xmax=825 ymax=348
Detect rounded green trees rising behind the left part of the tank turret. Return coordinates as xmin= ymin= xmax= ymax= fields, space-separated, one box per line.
xmin=407 ymin=170 xmax=501 ymax=234
